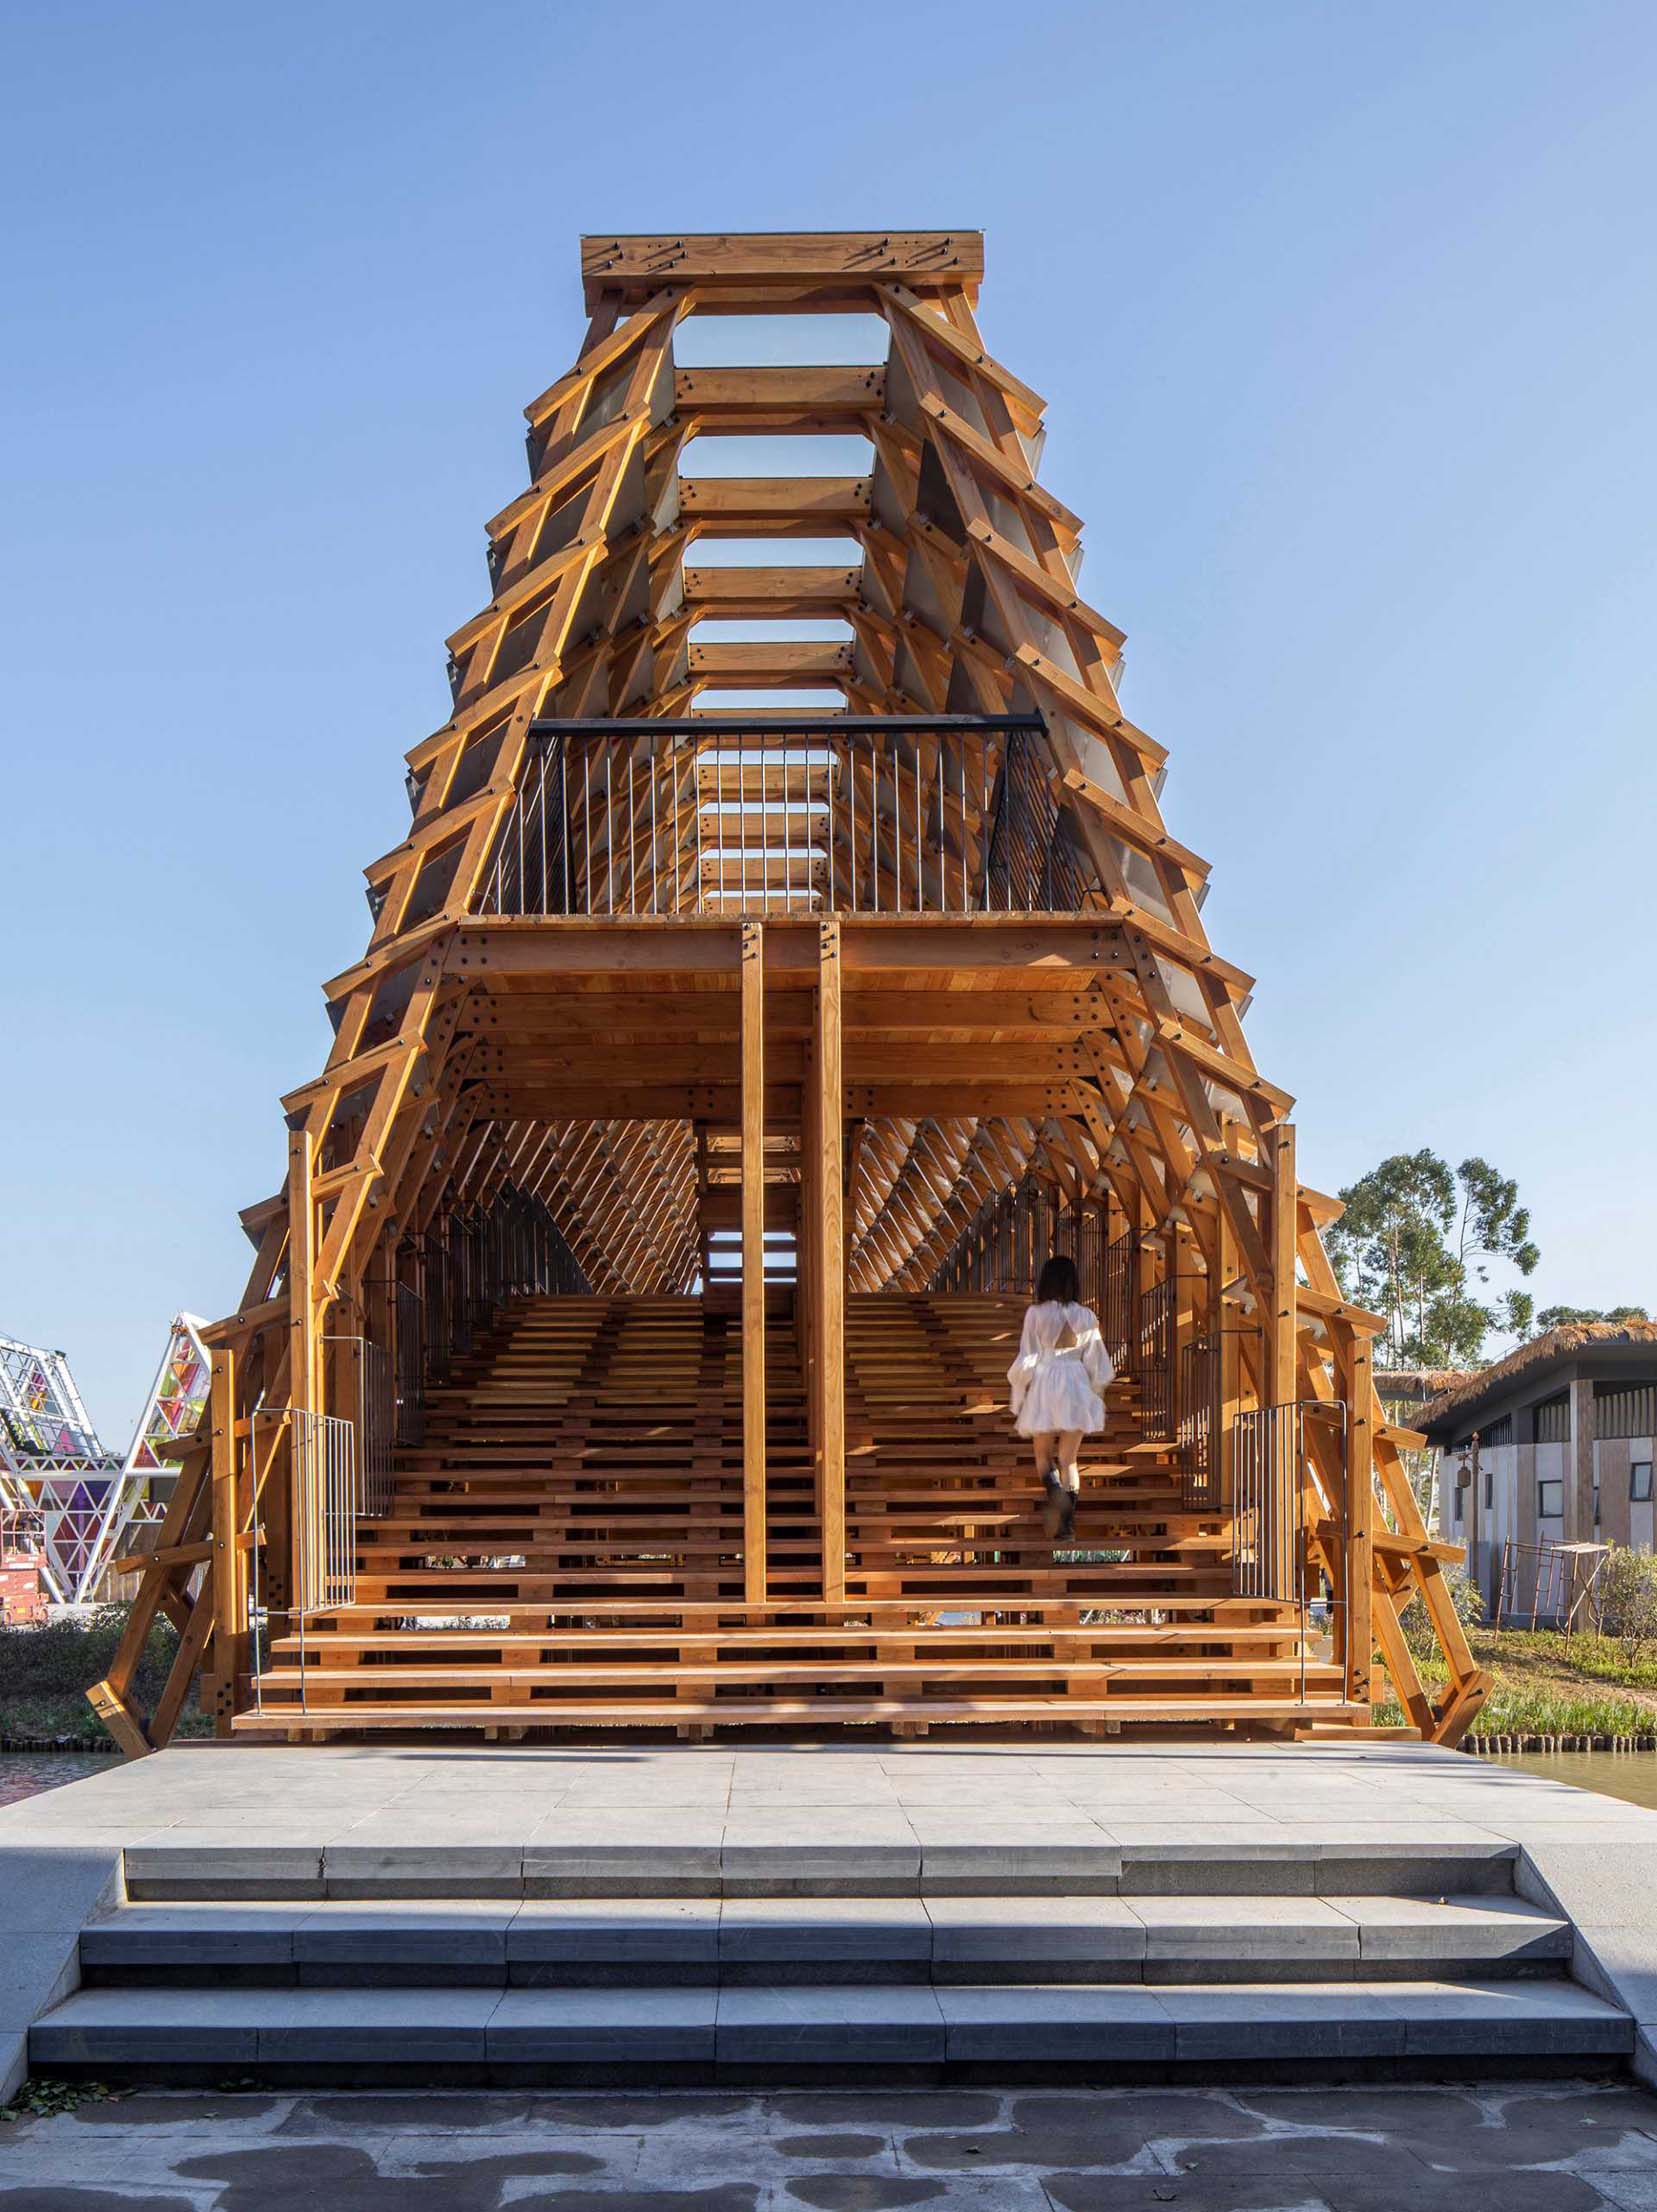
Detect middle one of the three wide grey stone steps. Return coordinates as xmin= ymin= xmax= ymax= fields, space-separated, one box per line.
xmin=80 ymin=1896 xmax=1571 ymax=1989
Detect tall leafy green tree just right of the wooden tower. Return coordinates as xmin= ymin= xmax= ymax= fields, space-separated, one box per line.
xmin=1327 ymin=1150 xmax=1542 ymax=1367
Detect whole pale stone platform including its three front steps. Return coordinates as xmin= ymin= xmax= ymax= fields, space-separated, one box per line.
xmin=0 ymin=1736 xmax=1657 ymax=2086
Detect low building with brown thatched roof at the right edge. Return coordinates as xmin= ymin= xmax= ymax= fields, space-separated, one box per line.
xmin=1416 ymin=1321 xmax=1657 ymax=1615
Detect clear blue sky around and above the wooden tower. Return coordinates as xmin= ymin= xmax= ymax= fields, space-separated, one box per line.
xmin=0 ymin=0 xmax=1657 ymax=1436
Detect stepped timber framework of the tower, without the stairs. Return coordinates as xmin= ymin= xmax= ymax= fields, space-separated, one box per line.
xmin=93 ymin=232 xmax=1487 ymax=1750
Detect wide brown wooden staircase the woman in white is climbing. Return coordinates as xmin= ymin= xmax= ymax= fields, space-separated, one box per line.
xmin=235 ymin=1294 xmax=1363 ymax=1736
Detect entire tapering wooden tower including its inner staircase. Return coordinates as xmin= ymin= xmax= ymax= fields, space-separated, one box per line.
xmin=91 ymin=232 xmax=1484 ymax=1752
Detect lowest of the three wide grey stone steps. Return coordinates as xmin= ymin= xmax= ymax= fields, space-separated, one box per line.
xmin=29 ymin=1978 xmax=1635 ymax=2086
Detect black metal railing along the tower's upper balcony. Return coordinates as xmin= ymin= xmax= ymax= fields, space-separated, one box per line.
xmin=482 ymin=714 xmax=1100 ymax=916
